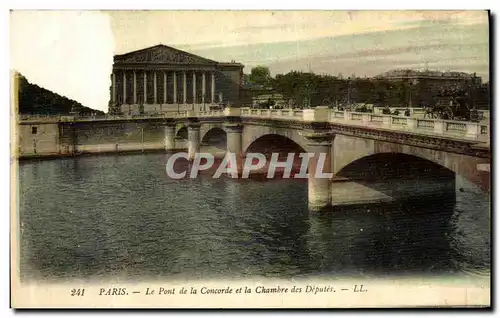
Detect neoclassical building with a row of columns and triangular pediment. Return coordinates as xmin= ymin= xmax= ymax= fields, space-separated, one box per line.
xmin=109 ymin=44 xmax=244 ymax=114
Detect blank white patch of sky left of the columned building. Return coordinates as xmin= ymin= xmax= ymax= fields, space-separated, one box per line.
xmin=10 ymin=11 xmax=114 ymax=112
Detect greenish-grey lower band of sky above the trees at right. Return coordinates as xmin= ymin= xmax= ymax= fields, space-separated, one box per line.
xmin=189 ymin=17 xmax=489 ymax=79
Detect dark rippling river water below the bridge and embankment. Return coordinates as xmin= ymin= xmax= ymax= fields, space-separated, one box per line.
xmin=19 ymin=153 xmax=490 ymax=280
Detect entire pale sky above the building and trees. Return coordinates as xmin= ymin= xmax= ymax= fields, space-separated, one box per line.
xmin=11 ymin=11 xmax=489 ymax=109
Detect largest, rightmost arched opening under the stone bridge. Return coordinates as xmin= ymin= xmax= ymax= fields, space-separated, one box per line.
xmin=332 ymin=153 xmax=456 ymax=204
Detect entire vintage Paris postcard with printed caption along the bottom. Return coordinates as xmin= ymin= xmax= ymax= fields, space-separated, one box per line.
xmin=10 ymin=10 xmax=493 ymax=309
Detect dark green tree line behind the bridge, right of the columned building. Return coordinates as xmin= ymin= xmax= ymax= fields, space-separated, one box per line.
xmin=243 ymin=66 xmax=490 ymax=108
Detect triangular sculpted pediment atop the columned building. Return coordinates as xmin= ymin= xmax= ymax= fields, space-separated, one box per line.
xmin=114 ymin=44 xmax=217 ymax=64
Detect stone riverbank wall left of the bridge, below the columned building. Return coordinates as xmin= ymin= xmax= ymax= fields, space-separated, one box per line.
xmin=12 ymin=122 xmax=181 ymax=160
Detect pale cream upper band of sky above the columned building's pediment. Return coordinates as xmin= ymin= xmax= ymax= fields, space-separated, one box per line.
xmin=106 ymin=10 xmax=487 ymax=53
